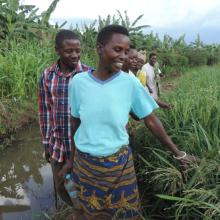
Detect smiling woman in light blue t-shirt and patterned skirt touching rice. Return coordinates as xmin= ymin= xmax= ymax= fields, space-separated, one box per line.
xmin=69 ymin=25 xmax=196 ymax=220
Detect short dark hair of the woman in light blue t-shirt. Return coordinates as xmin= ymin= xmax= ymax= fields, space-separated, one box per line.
xmin=96 ymin=24 xmax=129 ymax=45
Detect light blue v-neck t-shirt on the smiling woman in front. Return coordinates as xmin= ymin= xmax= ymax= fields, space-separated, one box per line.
xmin=69 ymin=71 xmax=158 ymax=157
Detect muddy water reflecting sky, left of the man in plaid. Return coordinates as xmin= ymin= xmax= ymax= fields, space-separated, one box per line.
xmin=0 ymin=126 xmax=55 ymax=220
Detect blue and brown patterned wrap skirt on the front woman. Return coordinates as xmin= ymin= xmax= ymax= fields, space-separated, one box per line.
xmin=73 ymin=146 xmax=140 ymax=220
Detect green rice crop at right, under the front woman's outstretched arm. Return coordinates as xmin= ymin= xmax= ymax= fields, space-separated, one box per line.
xmin=133 ymin=66 xmax=220 ymax=220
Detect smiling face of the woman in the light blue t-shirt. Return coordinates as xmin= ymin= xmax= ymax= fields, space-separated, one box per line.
xmin=97 ymin=33 xmax=130 ymax=74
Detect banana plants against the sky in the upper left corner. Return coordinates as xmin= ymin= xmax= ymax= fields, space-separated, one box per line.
xmin=0 ymin=0 xmax=62 ymax=45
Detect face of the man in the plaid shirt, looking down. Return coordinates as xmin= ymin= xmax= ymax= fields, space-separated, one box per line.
xmin=55 ymin=39 xmax=80 ymax=71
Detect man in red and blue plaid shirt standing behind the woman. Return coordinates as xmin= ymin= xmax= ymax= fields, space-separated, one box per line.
xmin=38 ymin=30 xmax=89 ymax=206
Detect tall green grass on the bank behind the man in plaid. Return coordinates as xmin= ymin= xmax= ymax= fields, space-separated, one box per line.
xmin=0 ymin=40 xmax=96 ymax=144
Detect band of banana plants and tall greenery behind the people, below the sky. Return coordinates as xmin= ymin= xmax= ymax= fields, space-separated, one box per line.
xmin=0 ymin=0 xmax=220 ymax=99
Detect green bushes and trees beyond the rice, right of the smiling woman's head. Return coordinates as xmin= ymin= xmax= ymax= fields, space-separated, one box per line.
xmin=132 ymin=32 xmax=220 ymax=73
